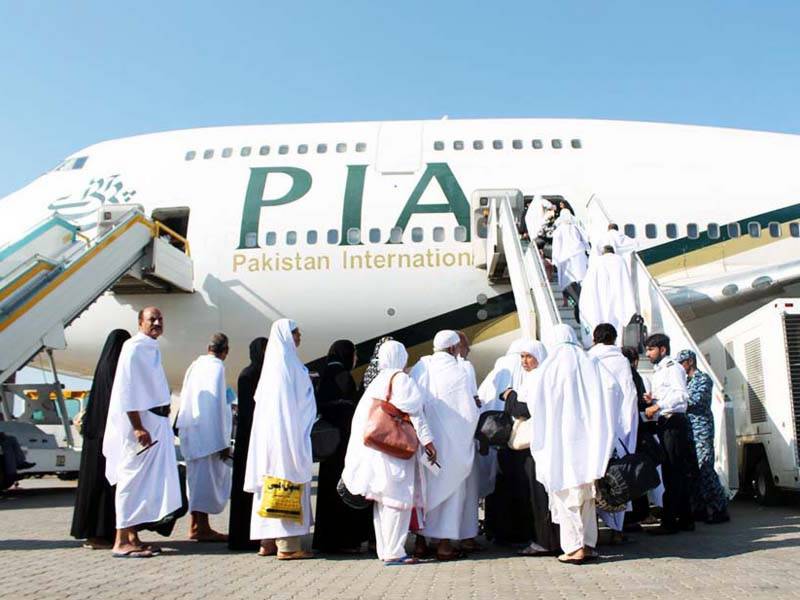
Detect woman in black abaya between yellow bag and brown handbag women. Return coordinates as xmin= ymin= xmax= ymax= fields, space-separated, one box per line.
xmin=313 ymin=340 xmax=372 ymax=553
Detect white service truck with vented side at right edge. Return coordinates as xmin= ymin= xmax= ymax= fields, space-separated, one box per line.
xmin=701 ymin=298 xmax=800 ymax=504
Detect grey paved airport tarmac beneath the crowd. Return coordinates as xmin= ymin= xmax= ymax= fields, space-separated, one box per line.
xmin=0 ymin=479 xmax=800 ymax=600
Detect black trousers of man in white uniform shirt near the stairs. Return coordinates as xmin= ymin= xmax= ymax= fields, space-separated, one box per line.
xmin=658 ymin=414 xmax=693 ymax=529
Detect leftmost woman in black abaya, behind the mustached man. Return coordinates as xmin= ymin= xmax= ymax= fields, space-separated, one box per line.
xmin=70 ymin=329 xmax=131 ymax=549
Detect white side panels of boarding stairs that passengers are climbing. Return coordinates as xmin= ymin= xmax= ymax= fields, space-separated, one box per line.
xmin=482 ymin=189 xmax=739 ymax=495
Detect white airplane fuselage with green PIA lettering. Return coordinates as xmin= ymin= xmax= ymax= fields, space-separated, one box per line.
xmin=0 ymin=119 xmax=800 ymax=387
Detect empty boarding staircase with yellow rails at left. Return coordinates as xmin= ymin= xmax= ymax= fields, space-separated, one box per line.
xmin=0 ymin=205 xmax=194 ymax=383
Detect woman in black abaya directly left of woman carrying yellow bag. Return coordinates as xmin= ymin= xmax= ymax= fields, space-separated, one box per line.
xmin=228 ymin=337 xmax=271 ymax=554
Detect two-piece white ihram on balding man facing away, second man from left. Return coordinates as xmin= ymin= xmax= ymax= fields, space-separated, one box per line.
xmin=175 ymin=354 xmax=233 ymax=514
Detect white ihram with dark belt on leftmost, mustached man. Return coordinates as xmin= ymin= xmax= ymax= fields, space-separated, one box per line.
xmin=103 ymin=333 xmax=181 ymax=529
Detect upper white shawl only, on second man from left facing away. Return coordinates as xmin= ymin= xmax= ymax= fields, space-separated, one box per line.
xmin=175 ymin=354 xmax=232 ymax=460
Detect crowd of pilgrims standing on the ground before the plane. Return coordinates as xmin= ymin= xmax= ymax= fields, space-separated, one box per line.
xmin=72 ymin=307 xmax=728 ymax=565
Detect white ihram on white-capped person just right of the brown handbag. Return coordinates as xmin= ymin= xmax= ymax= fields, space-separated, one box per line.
xmin=411 ymin=352 xmax=479 ymax=539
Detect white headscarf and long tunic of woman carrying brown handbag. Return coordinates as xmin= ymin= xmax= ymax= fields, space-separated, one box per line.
xmin=342 ymin=340 xmax=432 ymax=510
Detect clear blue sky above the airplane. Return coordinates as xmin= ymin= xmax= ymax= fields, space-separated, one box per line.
xmin=0 ymin=0 xmax=800 ymax=197
